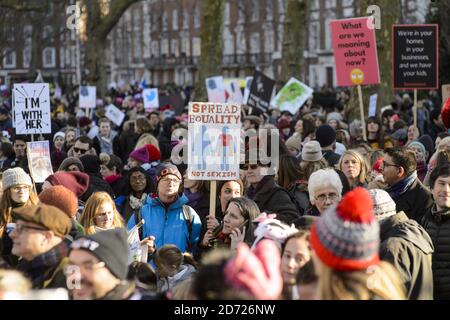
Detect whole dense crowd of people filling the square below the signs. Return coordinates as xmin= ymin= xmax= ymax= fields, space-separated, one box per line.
xmin=0 ymin=85 xmax=450 ymax=300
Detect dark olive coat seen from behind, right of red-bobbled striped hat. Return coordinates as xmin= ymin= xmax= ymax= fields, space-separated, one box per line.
xmin=380 ymin=212 xmax=434 ymax=300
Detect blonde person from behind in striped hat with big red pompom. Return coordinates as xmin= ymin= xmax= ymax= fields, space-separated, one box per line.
xmin=311 ymin=188 xmax=406 ymax=300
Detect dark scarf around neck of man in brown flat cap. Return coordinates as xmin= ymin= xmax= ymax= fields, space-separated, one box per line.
xmin=17 ymin=241 xmax=69 ymax=288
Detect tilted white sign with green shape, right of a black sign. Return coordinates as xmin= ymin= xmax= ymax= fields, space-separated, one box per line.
xmin=271 ymin=78 xmax=314 ymax=114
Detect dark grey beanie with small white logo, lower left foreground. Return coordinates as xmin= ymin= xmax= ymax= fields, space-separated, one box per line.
xmin=70 ymin=228 xmax=129 ymax=280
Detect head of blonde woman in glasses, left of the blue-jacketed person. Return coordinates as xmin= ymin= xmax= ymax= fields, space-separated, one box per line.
xmin=80 ymin=192 xmax=124 ymax=235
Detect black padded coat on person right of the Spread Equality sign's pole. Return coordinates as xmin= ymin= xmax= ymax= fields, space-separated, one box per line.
xmin=247 ymin=176 xmax=300 ymax=225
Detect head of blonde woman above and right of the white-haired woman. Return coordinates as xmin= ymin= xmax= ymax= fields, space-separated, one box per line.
xmin=338 ymin=150 xmax=370 ymax=189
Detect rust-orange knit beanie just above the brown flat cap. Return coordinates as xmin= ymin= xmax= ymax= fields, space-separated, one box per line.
xmin=39 ymin=186 xmax=78 ymax=218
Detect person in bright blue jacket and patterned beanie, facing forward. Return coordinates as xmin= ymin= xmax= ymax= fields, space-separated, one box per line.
xmin=127 ymin=163 xmax=202 ymax=255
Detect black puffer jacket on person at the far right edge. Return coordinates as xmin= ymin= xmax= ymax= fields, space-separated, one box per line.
xmin=422 ymin=207 xmax=450 ymax=300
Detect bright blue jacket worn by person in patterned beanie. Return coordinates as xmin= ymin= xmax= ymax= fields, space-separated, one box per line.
xmin=127 ymin=194 xmax=202 ymax=253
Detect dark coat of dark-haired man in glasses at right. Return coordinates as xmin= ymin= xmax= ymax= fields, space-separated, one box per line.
xmin=394 ymin=179 xmax=433 ymax=223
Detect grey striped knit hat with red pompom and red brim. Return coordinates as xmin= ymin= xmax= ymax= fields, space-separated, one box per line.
xmin=311 ymin=188 xmax=380 ymax=271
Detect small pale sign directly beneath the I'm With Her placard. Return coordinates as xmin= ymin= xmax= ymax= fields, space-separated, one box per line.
xmin=27 ymin=140 xmax=53 ymax=183
